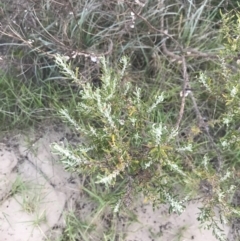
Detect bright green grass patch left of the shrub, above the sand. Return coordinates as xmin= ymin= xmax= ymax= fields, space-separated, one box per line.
xmin=0 ymin=69 xmax=81 ymax=130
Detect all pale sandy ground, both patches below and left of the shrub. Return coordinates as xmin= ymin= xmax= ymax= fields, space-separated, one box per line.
xmin=0 ymin=124 xmax=232 ymax=241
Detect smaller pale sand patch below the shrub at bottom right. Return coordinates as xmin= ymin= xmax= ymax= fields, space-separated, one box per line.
xmin=127 ymin=202 xmax=229 ymax=241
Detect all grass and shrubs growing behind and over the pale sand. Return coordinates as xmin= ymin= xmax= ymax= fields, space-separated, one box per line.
xmin=0 ymin=0 xmax=240 ymax=240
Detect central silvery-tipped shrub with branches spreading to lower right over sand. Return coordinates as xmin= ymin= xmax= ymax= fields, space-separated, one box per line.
xmin=53 ymin=49 xmax=235 ymax=237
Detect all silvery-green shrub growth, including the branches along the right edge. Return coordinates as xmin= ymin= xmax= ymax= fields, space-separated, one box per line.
xmin=53 ymin=12 xmax=240 ymax=237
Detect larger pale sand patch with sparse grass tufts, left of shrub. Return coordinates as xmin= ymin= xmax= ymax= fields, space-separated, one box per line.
xmin=0 ymin=126 xmax=80 ymax=241
